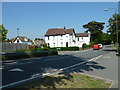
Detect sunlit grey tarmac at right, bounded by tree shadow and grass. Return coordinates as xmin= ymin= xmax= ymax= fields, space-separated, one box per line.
xmin=84 ymin=52 xmax=118 ymax=88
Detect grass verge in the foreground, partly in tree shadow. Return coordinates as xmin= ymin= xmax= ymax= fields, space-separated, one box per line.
xmin=17 ymin=73 xmax=112 ymax=90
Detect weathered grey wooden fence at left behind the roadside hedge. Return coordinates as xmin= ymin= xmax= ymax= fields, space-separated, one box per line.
xmin=2 ymin=42 xmax=27 ymax=53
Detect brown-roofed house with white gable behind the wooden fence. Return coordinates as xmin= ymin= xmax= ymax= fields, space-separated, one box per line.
xmin=9 ymin=36 xmax=33 ymax=45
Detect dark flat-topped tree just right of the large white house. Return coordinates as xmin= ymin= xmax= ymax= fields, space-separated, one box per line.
xmin=83 ymin=21 xmax=105 ymax=43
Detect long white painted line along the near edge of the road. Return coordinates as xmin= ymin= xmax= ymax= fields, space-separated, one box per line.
xmin=0 ymin=55 xmax=102 ymax=89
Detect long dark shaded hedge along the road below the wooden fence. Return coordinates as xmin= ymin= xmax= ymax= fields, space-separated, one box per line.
xmin=2 ymin=50 xmax=58 ymax=60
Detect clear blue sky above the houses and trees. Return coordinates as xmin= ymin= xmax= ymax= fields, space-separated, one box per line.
xmin=2 ymin=2 xmax=118 ymax=39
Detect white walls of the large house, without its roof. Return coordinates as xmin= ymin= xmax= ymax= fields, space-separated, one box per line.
xmin=45 ymin=33 xmax=90 ymax=47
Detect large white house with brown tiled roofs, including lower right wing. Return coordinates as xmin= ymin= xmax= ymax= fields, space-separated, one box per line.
xmin=45 ymin=27 xmax=90 ymax=47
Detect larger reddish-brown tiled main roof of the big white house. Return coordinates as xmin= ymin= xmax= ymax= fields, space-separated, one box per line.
xmin=45 ymin=28 xmax=74 ymax=36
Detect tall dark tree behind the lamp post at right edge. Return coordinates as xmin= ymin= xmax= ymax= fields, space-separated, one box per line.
xmin=107 ymin=14 xmax=120 ymax=46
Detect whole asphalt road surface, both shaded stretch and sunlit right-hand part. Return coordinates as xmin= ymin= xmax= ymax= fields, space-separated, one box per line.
xmin=0 ymin=46 xmax=118 ymax=88
